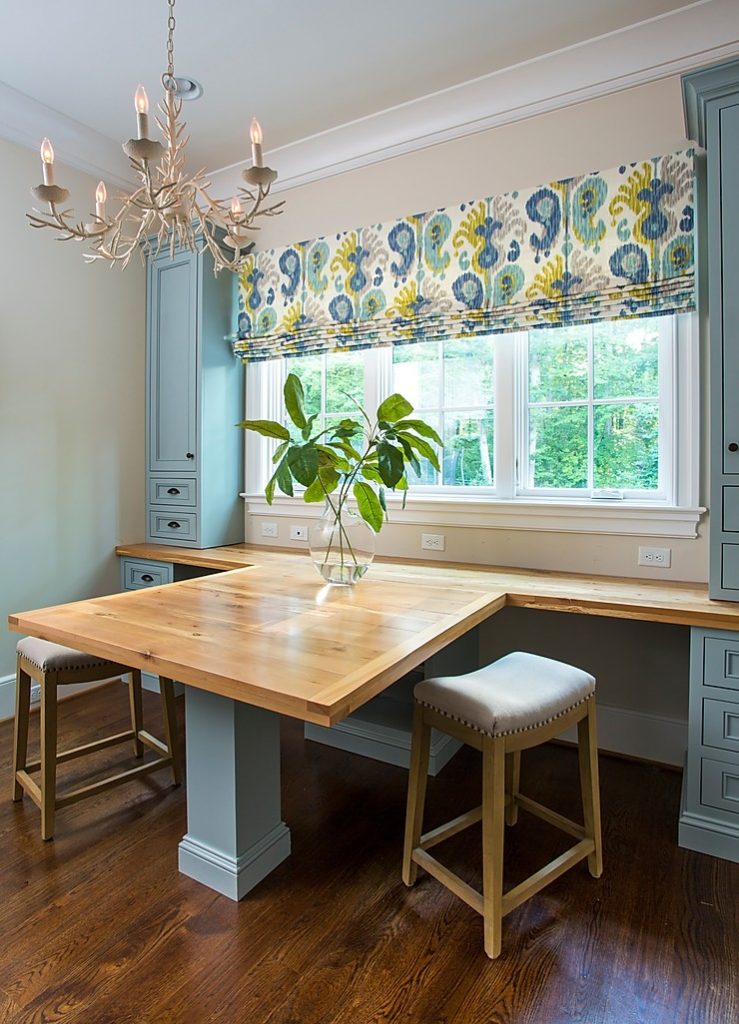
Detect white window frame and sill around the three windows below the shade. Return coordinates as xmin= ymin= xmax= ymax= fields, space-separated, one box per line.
xmin=242 ymin=313 xmax=705 ymax=538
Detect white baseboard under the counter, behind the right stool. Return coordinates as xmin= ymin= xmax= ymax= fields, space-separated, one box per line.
xmin=557 ymin=703 xmax=688 ymax=767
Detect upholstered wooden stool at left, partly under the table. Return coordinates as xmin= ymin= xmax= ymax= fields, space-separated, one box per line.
xmin=12 ymin=637 xmax=180 ymax=839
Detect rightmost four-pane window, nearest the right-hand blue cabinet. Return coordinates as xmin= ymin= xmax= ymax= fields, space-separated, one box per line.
xmin=519 ymin=317 xmax=675 ymax=500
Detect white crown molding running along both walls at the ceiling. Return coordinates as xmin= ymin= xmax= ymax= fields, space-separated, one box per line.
xmin=0 ymin=0 xmax=739 ymax=194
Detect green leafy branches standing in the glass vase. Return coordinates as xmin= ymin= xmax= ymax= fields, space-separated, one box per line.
xmin=238 ymin=374 xmax=442 ymax=548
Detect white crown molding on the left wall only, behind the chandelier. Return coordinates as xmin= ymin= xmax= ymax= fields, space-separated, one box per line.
xmin=0 ymin=82 xmax=133 ymax=190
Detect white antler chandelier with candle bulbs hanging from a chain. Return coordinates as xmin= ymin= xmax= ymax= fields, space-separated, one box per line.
xmin=27 ymin=0 xmax=284 ymax=272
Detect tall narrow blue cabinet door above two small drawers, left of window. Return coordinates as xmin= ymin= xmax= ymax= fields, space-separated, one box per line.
xmin=146 ymin=253 xmax=199 ymax=473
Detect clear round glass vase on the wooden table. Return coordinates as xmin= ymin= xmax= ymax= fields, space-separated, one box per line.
xmin=308 ymin=503 xmax=375 ymax=587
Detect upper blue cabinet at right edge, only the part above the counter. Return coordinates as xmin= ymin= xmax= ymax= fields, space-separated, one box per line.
xmin=683 ymin=60 xmax=739 ymax=601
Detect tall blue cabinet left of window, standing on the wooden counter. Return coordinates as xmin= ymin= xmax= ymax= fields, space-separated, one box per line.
xmin=146 ymin=246 xmax=244 ymax=548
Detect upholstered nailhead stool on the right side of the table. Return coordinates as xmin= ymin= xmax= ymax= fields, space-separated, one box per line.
xmin=402 ymin=652 xmax=603 ymax=957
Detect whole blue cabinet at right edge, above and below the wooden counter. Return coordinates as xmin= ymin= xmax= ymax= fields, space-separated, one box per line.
xmin=680 ymin=60 xmax=739 ymax=861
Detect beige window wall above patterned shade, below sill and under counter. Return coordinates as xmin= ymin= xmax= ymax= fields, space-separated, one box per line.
xmin=240 ymin=78 xmax=708 ymax=760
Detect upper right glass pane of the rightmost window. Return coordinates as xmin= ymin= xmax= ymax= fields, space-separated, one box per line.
xmin=593 ymin=319 xmax=659 ymax=398
